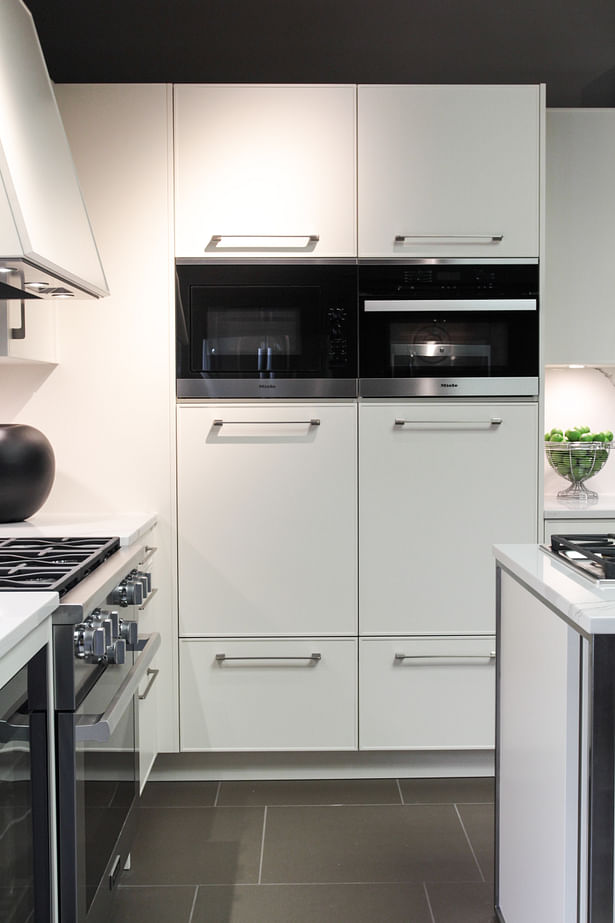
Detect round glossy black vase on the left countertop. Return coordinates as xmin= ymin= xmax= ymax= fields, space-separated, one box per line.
xmin=0 ymin=423 xmax=56 ymax=522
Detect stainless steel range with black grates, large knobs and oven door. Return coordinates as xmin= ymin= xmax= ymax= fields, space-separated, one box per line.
xmin=0 ymin=538 xmax=160 ymax=923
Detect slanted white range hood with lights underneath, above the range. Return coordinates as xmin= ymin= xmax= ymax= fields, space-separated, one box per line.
xmin=0 ymin=0 xmax=109 ymax=299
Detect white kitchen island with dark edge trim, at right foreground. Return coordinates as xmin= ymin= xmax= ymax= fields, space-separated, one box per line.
xmin=494 ymin=545 xmax=615 ymax=923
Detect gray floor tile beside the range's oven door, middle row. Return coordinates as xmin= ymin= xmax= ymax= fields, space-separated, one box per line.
xmin=122 ymin=808 xmax=264 ymax=885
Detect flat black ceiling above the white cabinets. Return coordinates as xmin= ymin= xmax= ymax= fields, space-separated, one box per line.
xmin=25 ymin=0 xmax=615 ymax=106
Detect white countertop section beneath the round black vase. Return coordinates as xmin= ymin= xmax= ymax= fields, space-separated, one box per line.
xmin=0 ymin=513 xmax=156 ymax=545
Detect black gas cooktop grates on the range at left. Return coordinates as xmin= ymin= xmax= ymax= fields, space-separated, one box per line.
xmin=0 ymin=538 xmax=120 ymax=596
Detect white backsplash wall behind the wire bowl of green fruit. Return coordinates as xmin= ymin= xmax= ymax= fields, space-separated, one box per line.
xmin=543 ymin=367 xmax=615 ymax=495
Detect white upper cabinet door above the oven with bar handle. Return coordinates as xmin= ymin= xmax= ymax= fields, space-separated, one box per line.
xmin=358 ymin=86 xmax=541 ymax=258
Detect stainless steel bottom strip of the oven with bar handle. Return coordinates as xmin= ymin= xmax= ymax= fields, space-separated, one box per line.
xmin=359 ymin=377 xmax=539 ymax=398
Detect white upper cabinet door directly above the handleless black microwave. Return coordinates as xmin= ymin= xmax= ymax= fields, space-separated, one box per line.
xmin=175 ymin=85 xmax=356 ymax=259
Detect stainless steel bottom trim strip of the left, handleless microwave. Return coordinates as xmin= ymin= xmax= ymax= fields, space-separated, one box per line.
xmin=177 ymin=378 xmax=357 ymax=400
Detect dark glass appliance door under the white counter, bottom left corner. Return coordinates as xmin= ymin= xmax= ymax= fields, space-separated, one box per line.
xmin=0 ymin=648 xmax=51 ymax=923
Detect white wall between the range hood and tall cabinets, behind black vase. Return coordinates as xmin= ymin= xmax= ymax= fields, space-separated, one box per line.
xmin=0 ymin=84 xmax=177 ymax=750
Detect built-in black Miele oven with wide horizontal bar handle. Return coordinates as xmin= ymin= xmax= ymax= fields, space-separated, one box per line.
xmin=358 ymin=259 xmax=539 ymax=398
